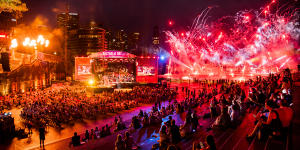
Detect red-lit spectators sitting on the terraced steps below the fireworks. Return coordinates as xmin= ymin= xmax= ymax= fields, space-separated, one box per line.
xmin=110 ymin=69 xmax=293 ymax=150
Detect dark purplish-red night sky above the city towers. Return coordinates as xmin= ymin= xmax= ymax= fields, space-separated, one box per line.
xmin=23 ymin=0 xmax=276 ymax=44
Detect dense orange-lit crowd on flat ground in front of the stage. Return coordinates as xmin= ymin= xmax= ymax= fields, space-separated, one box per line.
xmin=1 ymin=85 xmax=176 ymax=127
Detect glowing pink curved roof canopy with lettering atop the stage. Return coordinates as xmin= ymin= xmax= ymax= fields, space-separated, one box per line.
xmin=89 ymin=51 xmax=136 ymax=59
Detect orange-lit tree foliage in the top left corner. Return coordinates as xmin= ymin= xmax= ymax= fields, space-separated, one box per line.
xmin=0 ymin=0 xmax=28 ymax=13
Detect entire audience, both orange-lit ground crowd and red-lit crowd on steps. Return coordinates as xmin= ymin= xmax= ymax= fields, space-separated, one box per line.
xmin=0 ymin=69 xmax=293 ymax=150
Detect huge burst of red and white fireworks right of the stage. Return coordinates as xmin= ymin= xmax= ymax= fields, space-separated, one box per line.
xmin=165 ymin=0 xmax=300 ymax=76
